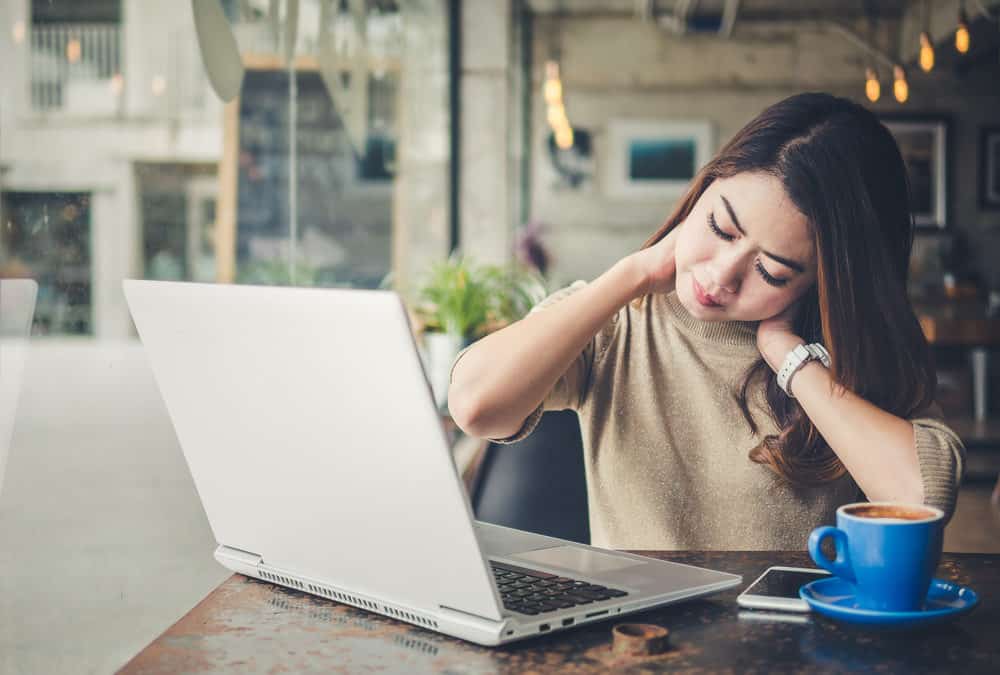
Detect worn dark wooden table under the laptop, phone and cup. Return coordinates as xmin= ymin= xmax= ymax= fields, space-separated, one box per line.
xmin=121 ymin=551 xmax=1000 ymax=674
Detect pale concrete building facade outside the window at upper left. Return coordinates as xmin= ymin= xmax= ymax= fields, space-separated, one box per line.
xmin=0 ymin=0 xmax=222 ymax=338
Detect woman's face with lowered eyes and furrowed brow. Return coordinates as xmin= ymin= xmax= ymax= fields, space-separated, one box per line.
xmin=675 ymin=173 xmax=816 ymax=321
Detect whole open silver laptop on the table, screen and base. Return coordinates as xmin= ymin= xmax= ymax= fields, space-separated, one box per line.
xmin=124 ymin=280 xmax=742 ymax=645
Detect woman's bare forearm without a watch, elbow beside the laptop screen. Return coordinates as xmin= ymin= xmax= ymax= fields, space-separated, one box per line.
xmin=448 ymin=257 xmax=642 ymax=438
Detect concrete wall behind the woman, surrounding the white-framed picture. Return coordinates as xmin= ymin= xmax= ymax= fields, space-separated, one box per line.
xmin=524 ymin=15 xmax=1000 ymax=284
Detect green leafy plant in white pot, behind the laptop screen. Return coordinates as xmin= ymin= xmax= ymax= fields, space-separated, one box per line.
xmin=414 ymin=254 xmax=545 ymax=408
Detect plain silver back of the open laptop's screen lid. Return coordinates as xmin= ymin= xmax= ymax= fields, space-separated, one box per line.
xmin=125 ymin=281 xmax=500 ymax=619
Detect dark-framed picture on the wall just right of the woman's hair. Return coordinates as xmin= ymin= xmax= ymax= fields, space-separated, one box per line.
xmin=882 ymin=117 xmax=948 ymax=228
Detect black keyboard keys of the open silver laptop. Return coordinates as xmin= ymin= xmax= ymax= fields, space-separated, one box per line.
xmin=490 ymin=560 xmax=628 ymax=615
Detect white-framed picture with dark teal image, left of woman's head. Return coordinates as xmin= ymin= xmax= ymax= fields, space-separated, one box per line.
xmin=605 ymin=120 xmax=714 ymax=201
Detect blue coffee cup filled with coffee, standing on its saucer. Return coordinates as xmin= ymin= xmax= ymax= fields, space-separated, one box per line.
xmin=809 ymin=502 xmax=944 ymax=612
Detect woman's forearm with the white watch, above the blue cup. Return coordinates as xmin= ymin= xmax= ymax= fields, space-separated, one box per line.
xmin=765 ymin=340 xmax=924 ymax=503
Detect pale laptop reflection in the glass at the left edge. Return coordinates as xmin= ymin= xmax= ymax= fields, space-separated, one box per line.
xmin=0 ymin=279 xmax=38 ymax=496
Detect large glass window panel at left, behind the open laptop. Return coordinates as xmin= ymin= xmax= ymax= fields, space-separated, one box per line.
xmin=0 ymin=0 xmax=450 ymax=673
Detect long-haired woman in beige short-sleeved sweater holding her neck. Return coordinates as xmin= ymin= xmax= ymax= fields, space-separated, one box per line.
xmin=449 ymin=94 xmax=964 ymax=550
